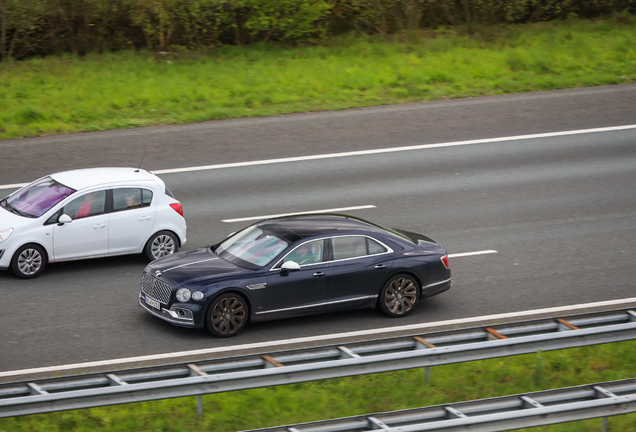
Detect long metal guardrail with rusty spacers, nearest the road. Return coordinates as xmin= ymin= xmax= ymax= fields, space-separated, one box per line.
xmin=0 ymin=309 xmax=636 ymax=417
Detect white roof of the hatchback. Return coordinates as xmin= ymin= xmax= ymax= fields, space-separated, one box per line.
xmin=51 ymin=168 xmax=164 ymax=190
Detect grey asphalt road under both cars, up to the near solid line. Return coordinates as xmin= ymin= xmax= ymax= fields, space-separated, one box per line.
xmin=0 ymin=86 xmax=636 ymax=371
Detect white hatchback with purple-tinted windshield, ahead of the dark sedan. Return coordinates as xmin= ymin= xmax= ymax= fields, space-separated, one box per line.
xmin=0 ymin=168 xmax=187 ymax=278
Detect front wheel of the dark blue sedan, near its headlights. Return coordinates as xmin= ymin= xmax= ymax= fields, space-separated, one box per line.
xmin=205 ymin=293 xmax=249 ymax=337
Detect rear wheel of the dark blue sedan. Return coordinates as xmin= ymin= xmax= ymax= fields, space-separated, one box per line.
xmin=380 ymin=274 xmax=420 ymax=318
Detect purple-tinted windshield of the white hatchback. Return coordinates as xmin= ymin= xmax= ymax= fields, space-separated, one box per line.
xmin=0 ymin=177 xmax=75 ymax=218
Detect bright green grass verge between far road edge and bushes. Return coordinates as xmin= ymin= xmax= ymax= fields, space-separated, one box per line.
xmin=0 ymin=15 xmax=636 ymax=138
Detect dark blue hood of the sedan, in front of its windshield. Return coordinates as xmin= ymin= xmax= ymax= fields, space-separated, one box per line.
xmin=144 ymin=248 xmax=250 ymax=287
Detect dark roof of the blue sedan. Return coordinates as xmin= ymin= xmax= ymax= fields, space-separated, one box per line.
xmin=256 ymin=214 xmax=396 ymax=242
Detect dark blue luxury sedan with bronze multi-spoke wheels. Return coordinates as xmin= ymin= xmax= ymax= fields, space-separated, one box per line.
xmin=139 ymin=215 xmax=451 ymax=337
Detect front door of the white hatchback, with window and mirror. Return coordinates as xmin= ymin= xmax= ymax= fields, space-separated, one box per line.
xmin=53 ymin=190 xmax=108 ymax=261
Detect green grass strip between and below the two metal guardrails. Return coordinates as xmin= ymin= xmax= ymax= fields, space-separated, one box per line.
xmin=0 ymin=341 xmax=636 ymax=432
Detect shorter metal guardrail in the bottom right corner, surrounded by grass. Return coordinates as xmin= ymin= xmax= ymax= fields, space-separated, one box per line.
xmin=245 ymin=379 xmax=636 ymax=432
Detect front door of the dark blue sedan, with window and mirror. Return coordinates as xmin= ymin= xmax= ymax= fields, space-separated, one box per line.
xmin=266 ymin=239 xmax=329 ymax=318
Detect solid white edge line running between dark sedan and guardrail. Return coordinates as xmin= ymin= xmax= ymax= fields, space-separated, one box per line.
xmin=0 ymin=297 xmax=636 ymax=377
